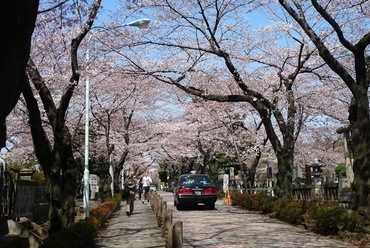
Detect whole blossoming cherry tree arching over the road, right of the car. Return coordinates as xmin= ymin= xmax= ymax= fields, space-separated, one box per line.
xmin=110 ymin=1 xmax=346 ymax=197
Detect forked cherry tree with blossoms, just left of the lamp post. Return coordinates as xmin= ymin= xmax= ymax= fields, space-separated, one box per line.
xmin=23 ymin=1 xmax=104 ymax=232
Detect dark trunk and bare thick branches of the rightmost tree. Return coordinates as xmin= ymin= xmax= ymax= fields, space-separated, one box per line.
xmin=279 ymin=0 xmax=370 ymax=217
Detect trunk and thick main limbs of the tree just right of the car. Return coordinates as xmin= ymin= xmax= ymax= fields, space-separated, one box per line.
xmin=166 ymin=44 xmax=304 ymax=198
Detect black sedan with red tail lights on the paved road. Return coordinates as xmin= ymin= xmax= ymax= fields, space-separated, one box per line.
xmin=174 ymin=174 xmax=217 ymax=210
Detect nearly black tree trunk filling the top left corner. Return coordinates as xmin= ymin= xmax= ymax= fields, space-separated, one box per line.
xmin=0 ymin=0 xmax=39 ymax=148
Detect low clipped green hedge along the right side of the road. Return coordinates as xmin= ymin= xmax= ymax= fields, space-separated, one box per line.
xmin=230 ymin=192 xmax=370 ymax=235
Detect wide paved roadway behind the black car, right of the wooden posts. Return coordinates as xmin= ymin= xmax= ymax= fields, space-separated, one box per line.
xmin=160 ymin=192 xmax=356 ymax=248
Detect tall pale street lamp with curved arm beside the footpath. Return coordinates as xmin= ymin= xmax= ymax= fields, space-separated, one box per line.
xmin=83 ymin=18 xmax=150 ymax=218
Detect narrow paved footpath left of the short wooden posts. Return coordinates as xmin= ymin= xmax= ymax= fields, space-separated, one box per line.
xmin=94 ymin=200 xmax=165 ymax=248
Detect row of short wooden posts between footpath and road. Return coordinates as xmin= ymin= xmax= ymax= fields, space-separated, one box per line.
xmin=149 ymin=190 xmax=183 ymax=248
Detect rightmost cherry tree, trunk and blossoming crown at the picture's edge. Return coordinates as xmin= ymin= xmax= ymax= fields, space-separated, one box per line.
xmin=279 ymin=0 xmax=370 ymax=216
